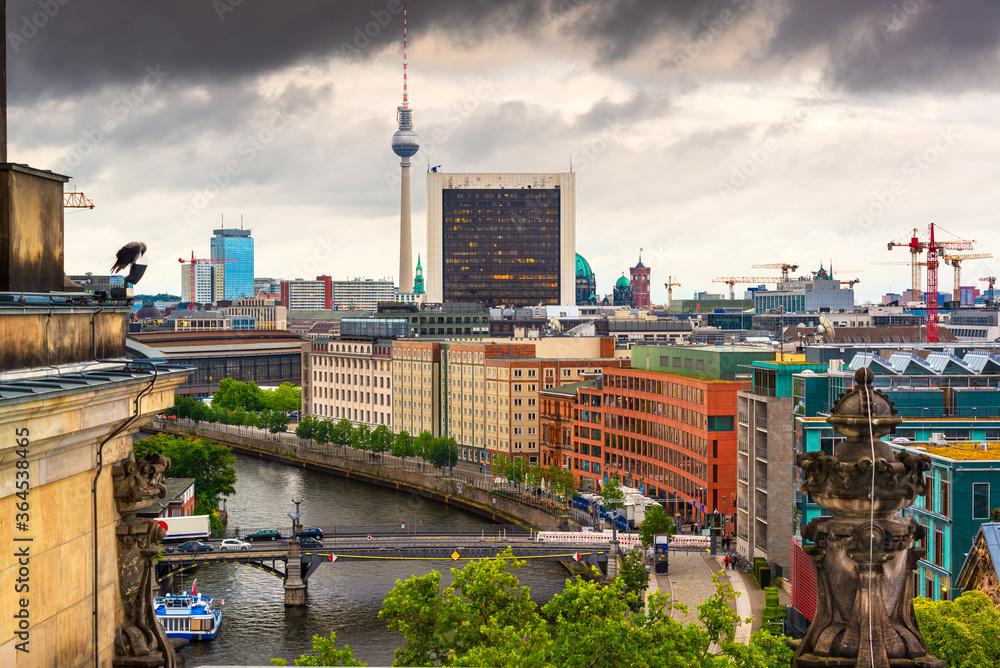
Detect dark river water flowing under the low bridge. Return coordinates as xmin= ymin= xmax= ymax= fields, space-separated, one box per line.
xmin=179 ymin=455 xmax=567 ymax=666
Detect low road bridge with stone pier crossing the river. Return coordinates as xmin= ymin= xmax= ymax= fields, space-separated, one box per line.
xmin=156 ymin=527 xmax=612 ymax=605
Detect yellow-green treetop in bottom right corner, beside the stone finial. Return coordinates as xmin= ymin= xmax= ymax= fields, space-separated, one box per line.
xmin=913 ymin=590 xmax=1000 ymax=668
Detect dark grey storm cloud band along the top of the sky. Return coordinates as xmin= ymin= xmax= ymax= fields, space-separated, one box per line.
xmin=7 ymin=0 xmax=1000 ymax=103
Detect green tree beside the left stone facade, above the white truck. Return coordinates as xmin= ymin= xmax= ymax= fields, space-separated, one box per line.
xmin=134 ymin=434 xmax=236 ymax=508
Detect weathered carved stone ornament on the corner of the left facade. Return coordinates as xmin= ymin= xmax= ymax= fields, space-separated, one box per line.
xmin=111 ymin=455 xmax=183 ymax=668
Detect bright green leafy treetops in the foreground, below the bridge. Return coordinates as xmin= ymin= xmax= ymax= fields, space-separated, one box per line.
xmin=379 ymin=550 xmax=764 ymax=668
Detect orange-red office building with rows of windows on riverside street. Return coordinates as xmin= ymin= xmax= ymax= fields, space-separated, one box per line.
xmin=556 ymin=368 xmax=743 ymax=525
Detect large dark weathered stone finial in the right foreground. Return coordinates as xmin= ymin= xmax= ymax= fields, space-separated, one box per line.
xmin=790 ymin=368 xmax=945 ymax=668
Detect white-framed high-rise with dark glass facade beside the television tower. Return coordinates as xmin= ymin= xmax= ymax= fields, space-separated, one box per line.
xmin=427 ymin=172 xmax=576 ymax=306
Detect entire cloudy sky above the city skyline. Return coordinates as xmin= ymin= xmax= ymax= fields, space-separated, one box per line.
xmin=7 ymin=0 xmax=1000 ymax=302
